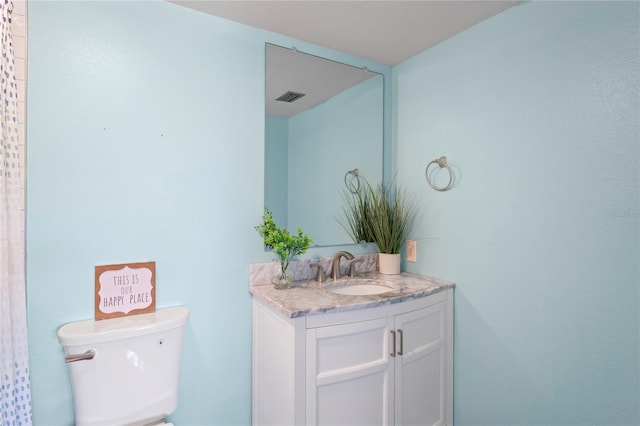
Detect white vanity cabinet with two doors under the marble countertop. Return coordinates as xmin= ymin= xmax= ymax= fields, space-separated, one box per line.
xmin=253 ymin=289 xmax=453 ymax=426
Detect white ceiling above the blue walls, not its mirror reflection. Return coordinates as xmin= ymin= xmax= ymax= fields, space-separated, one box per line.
xmin=172 ymin=0 xmax=518 ymax=66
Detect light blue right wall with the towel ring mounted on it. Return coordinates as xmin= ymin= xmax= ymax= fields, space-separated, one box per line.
xmin=393 ymin=2 xmax=640 ymax=425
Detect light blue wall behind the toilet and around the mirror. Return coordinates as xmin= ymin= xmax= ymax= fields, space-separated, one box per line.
xmin=26 ymin=1 xmax=390 ymax=425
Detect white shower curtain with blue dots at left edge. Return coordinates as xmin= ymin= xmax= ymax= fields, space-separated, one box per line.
xmin=0 ymin=0 xmax=31 ymax=426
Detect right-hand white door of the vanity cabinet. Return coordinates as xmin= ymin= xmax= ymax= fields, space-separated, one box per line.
xmin=395 ymin=302 xmax=448 ymax=426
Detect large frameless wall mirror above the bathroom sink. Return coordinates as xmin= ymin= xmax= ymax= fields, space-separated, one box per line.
xmin=264 ymin=43 xmax=384 ymax=246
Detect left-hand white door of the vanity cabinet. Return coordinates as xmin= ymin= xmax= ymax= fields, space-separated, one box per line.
xmin=306 ymin=317 xmax=393 ymax=426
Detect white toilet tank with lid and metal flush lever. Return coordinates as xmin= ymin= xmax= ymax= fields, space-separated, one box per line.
xmin=58 ymin=306 xmax=189 ymax=426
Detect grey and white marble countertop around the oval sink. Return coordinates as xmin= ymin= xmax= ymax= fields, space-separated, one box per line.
xmin=249 ymin=272 xmax=455 ymax=318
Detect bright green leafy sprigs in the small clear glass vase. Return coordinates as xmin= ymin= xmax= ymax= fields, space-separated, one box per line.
xmin=256 ymin=208 xmax=313 ymax=279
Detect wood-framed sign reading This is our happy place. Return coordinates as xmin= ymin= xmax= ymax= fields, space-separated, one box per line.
xmin=95 ymin=262 xmax=156 ymax=320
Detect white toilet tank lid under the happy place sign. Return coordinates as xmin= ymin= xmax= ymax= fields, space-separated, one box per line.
xmin=58 ymin=306 xmax=189 ymax=346
